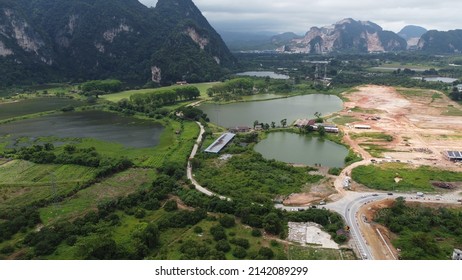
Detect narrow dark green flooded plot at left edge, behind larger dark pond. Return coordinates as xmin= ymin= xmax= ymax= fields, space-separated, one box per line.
xmin=0 ymin=97 xmax=84 ymax=120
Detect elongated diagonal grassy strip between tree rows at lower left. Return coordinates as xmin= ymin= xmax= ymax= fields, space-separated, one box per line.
xmin=39 ymin=168 xmax=156 ymax=225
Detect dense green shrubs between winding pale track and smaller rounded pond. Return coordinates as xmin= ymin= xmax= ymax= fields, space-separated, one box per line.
xmin=195 ymin=150 xmax=321 ymax=202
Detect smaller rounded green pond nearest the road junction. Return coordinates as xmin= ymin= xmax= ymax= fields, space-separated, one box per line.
xmin=255 ymin=132 xmax=348 ymax=167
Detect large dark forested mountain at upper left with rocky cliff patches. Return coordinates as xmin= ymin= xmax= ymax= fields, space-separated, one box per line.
xmin=0 ymin=0 xmax=236 ymax=85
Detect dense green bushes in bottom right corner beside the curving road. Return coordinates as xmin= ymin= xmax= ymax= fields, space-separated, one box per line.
xmin=375 ymin=198 xmax=462 ymax=260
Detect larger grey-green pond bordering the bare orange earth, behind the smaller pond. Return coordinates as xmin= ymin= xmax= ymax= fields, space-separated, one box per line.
xmin=199 ymin=94 xmax=342 ymax=128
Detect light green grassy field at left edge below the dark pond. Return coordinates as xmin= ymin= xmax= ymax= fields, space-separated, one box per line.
xmin=0 ymin=160 xmax=96 ymax=208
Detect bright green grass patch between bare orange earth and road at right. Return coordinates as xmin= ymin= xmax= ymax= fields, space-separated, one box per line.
xmin=351 ymin=163 xmax=462 ymax=192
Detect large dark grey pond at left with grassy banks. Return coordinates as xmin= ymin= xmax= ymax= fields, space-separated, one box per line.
xmin=0 ymin=111 xmax=164 ymax=148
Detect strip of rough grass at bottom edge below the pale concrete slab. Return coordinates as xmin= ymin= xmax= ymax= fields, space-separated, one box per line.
xmin=287 ymin=245 xmax=356 ymax=260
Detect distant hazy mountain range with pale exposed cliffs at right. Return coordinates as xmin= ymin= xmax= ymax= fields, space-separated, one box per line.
xmin=224 ymin=18 xmax=462 ymax=54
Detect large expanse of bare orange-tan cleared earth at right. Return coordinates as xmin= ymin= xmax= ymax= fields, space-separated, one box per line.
xmin=340 ymin=85 xmax=462 ymax=171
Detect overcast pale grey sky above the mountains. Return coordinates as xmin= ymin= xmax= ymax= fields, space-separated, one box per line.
xmin=140 ymin=0 xmax=462 ymax=34
